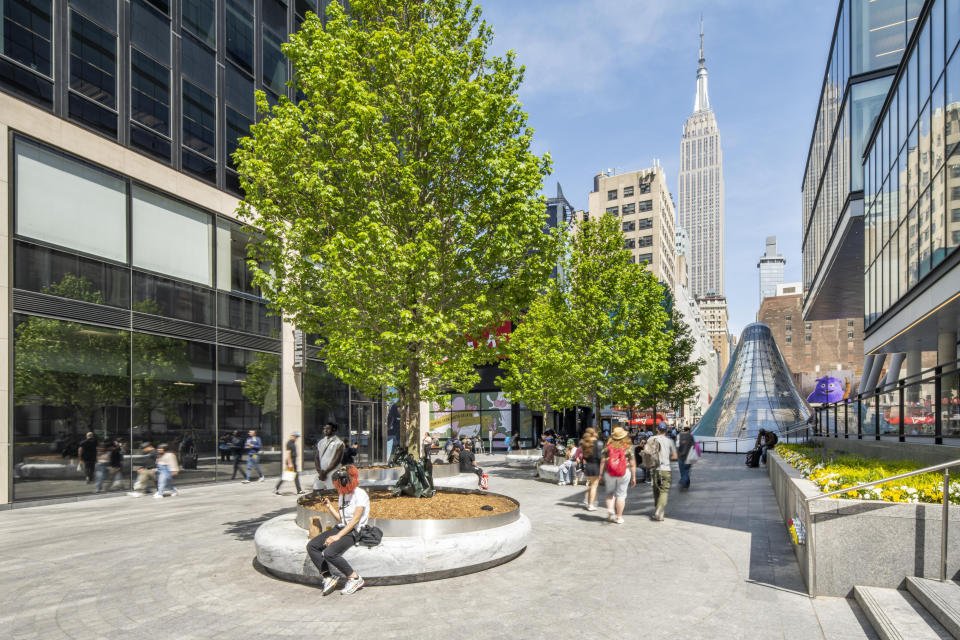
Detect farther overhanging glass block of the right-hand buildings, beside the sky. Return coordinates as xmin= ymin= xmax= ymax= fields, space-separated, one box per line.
xmin=802 ymin=0 xmax=923 ymax=320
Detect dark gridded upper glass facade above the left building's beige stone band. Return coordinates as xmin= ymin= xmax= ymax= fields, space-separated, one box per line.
xmin=0 ymin=0 xmax=318 ymax=195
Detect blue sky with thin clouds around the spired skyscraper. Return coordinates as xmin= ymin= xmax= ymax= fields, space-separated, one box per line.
xmin=478 ymin=0 xmax=838 ymax=336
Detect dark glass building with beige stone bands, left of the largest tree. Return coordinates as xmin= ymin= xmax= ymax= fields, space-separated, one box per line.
xmin=0 ymin=0 xmax=398 ymax=505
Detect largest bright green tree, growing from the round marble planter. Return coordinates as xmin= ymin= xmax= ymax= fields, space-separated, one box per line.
xmin=234 ymin=0 xmax=558 ymax=455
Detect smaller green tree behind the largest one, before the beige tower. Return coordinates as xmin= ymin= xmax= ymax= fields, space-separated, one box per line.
xmin=500 ymin=216 xmax=671 ymax=426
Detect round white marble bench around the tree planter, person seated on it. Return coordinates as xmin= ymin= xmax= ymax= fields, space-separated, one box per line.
xmin=254 ymin=488 xmax=531 ymax=585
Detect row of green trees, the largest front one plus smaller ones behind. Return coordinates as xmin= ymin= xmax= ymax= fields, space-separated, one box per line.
xmin=233 ymin=0 xmax=696 ymax=454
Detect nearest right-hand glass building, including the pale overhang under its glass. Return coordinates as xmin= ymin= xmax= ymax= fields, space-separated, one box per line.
xmin=862 ymin=0 xmax=960 ymax=364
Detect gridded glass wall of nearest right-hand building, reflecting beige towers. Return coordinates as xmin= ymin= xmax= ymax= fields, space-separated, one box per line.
xmin=863 ymin=0 xmax=960 ymax=327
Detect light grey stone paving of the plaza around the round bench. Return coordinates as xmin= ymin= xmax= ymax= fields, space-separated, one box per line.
xmin=0 ymin=454 xmax=875 ymax=640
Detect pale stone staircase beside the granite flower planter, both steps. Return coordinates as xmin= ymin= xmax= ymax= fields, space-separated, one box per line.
xmin=853 ymin=578 xmax=960 ymax=640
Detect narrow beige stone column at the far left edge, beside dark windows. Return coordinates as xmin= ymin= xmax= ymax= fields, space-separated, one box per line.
xmin=0 ymin=124 xmax=13 ymax=504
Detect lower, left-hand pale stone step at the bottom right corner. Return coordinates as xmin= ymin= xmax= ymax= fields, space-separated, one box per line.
xmin=853 ymin=586 xmax=952 ymax=640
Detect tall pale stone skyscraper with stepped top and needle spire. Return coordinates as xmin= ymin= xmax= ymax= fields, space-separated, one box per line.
xmin=679 ymin=21 xmax=723 ymax=297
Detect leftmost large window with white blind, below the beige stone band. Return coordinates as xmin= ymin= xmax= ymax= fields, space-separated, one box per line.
xmin=14 ymin=140 xmax=127 ymax=262
